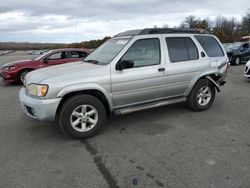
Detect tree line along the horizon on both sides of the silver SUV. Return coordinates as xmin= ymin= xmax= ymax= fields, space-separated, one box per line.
xmin=0 ymin=9 xmax=250 ymax=50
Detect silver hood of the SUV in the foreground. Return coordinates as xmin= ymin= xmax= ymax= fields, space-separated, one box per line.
xmin=25 ymin=61 xmax=110 ymax=86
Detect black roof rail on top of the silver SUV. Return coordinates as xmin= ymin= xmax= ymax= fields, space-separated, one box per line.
xmin=139 ymin=28 xmax=210 ymax=35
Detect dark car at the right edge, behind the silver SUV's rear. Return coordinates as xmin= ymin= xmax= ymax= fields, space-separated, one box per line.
xmin=225 ymin=42 xmax=250 ymax=65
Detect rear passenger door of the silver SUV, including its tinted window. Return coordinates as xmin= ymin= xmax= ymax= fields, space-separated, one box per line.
xmin=164 ymin=35 xmax=208 ymax=98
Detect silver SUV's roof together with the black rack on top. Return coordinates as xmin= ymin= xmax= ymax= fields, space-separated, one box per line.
xmin=116 ymin=28 xmax=210 ymax=37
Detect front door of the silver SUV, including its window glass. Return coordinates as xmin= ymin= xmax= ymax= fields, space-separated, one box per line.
xmin=111 ymin=37 xmax=166 ymax=107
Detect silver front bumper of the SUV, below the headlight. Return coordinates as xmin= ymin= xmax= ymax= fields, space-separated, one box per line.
xmin=19 ymin=88 xmax=61 ymax=121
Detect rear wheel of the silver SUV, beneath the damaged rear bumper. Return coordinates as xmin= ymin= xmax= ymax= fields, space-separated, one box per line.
xmin=187 ymin=79 xmax=216 ymax=111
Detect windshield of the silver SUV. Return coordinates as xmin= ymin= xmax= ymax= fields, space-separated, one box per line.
xmin=84 ymin=38 xmax=130 ymax=65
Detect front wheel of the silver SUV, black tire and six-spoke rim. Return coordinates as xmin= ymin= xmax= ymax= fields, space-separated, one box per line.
xmin=58 ymin=94 xmax=106 ymax=139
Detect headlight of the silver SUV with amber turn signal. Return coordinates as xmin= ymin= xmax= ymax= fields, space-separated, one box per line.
xmin=26 ymin=84 xmax=49 ymax=97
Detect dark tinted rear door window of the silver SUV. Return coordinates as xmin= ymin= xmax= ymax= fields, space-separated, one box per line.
xmin=166 ymin=37 xmax=199 ymax=63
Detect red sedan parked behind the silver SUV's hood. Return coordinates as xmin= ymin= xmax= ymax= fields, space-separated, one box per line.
xmin=0 ymin=48 xmax=91 ymax=83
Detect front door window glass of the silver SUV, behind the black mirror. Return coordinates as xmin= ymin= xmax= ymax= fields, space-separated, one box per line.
xmin=122 ymin=39 xmax=160 ymax=67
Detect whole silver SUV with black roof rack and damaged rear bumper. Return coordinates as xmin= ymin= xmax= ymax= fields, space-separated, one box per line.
xmin=19 ymin=29 xmax=229 ymax=139
